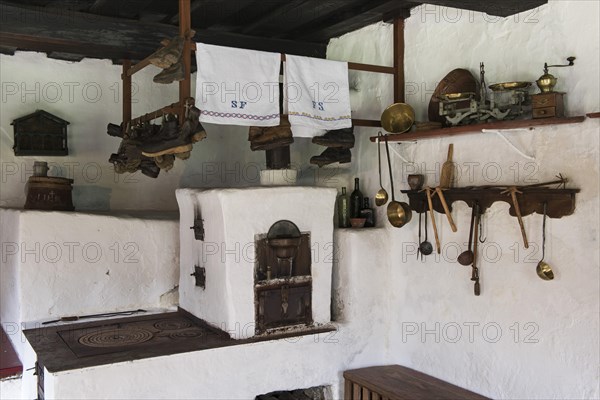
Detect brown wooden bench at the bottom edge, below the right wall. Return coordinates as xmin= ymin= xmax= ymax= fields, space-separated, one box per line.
xmin=344 ymin=365 xmax=487 ymax=400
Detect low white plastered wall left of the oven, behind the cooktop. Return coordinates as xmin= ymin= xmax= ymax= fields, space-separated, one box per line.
xmin=0 ymin=209 xmax=179 ymax=356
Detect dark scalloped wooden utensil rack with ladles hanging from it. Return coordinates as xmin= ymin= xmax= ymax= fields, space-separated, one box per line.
xmin=402 ymin=187 xmax=580 ymax=218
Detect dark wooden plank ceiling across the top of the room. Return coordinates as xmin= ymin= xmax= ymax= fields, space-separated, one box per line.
xmin=0 ymin=0 xmax=547 ymax=60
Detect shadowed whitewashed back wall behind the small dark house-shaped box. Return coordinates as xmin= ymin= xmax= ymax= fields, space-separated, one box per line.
xmin=0 ymin=52 xmax=350 ymax=210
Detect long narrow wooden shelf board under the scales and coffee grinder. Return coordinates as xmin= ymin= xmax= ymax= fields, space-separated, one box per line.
xmin=370 ymin=116 xmax=585 ymax=142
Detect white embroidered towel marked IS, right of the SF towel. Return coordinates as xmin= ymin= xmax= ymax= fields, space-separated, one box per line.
xmin=285 ymin=54 xmax=352 ymax=131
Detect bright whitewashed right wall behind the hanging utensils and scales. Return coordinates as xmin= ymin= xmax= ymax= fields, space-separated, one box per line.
xmin=328 ymin=1 xmax=600 ymax=399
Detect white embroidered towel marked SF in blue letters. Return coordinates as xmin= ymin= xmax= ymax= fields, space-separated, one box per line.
xmin=196 ymin=43 xmax=281 ymax=126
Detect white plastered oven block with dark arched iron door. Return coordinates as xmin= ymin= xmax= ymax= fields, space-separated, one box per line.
xmin=177 ymin=187 xmax=337 ymax=339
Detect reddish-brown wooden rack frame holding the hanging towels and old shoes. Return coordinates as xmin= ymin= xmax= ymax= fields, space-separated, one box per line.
xmin=121 ymin=0 xmax=405 ymax=129
